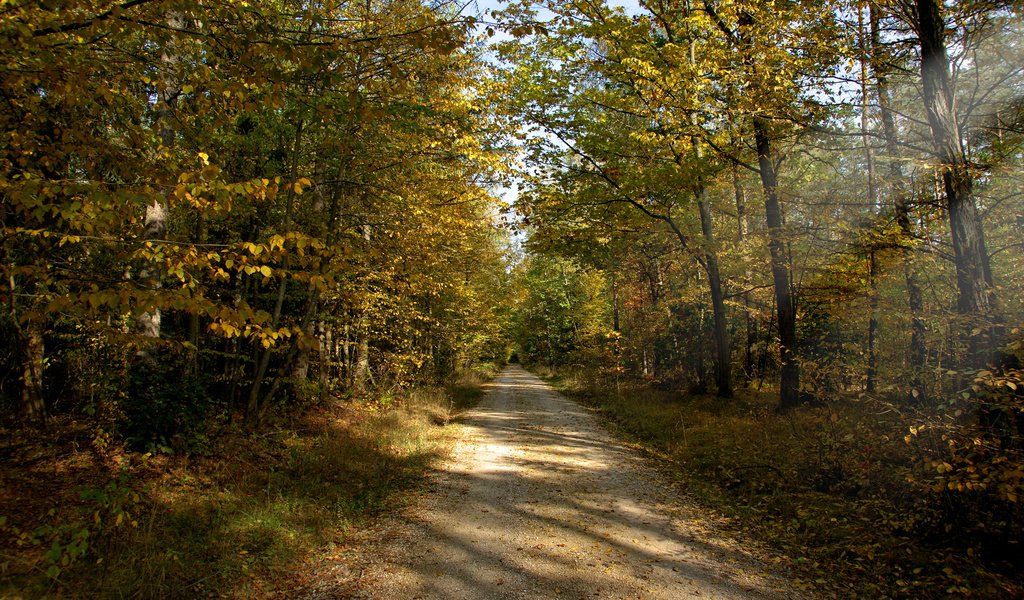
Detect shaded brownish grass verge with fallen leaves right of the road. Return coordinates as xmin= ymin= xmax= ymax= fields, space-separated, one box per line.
xmin=541 ymin=371 xmax=1024 ymax=598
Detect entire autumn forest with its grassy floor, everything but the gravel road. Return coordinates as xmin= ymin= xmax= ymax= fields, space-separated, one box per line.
xmin=0 ymin=0 xmax=1024 ymax=598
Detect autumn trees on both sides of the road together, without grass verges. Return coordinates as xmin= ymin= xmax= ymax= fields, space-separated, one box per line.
xmin=0 ymin=0 xmax=1024 ymax=593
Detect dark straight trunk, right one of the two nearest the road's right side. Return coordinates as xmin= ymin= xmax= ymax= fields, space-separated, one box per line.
xmin=754 ymin=118 xmax=800 ymax=411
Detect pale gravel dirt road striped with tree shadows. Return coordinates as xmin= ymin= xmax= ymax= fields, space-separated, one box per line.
xmin=319 ymin=367 xmax=797 ymax=600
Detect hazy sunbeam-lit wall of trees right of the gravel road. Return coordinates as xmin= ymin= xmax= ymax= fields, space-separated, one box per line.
xmin=502 ymin=0 xmax=1024 ymax=561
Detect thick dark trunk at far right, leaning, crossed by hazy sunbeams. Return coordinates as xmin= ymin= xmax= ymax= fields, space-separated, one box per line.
xmin=914 ymin=0 xmax=994 ymax=368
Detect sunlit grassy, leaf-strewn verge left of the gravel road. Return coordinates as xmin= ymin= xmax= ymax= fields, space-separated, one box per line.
xmin=0 ymin=370 xmax=482 ymax=599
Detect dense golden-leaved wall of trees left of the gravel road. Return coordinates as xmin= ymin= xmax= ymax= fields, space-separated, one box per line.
xmin=0 ymin=0 xmax=506 ymax=447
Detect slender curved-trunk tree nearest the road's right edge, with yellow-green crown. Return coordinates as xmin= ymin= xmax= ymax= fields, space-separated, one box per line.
xmin=497 ymin=2 xmax=745 ymax=397
